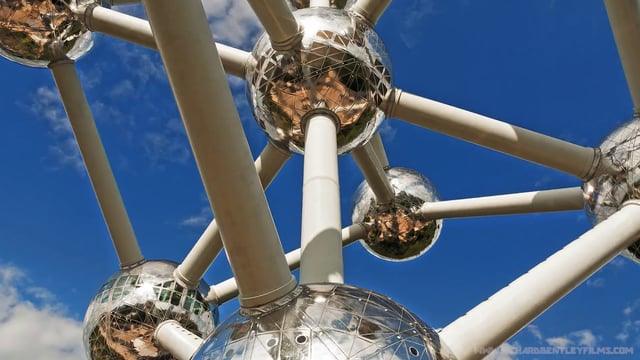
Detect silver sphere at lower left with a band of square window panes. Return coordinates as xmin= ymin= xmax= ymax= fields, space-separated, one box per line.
xmin=84 ymin=261 xmax=218 ymax=360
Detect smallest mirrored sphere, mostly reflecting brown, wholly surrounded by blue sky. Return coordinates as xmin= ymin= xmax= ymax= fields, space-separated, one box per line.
xmin=351 ymin=167 xmax=442 ymax=261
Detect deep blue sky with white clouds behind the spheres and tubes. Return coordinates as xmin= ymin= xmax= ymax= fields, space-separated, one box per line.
xmin=0 ymin=0 xmax=640 ymax=360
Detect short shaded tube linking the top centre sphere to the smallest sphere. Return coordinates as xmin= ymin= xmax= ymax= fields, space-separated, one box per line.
xmin=351 ymin=143 xmax=395 ymax=203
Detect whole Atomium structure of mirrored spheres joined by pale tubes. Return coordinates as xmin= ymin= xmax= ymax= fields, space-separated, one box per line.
xmin=0 ymin=0 xmax=640 ymax=360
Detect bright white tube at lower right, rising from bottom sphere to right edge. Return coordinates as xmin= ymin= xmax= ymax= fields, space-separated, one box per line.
xmin=440 ymin=202 xmax=640 ymax=360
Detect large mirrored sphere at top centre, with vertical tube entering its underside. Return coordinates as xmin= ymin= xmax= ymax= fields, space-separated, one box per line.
xmin=246 ymin=8 xmax=391 ymax=154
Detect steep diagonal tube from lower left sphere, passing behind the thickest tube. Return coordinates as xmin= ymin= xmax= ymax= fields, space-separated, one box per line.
xmin=174 ymin=143 xmax=291 ymax=288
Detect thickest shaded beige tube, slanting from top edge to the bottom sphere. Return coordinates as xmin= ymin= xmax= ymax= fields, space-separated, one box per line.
xmin=143 ymin=0 xmax=296 ymax=307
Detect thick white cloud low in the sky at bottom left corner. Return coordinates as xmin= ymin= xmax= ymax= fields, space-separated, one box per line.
xmin=0 ymin=265 xmax=85 ymax=360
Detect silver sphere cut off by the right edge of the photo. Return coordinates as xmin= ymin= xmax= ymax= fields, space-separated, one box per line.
xmin=583 ymin=117 xmax=640 ymax=264
